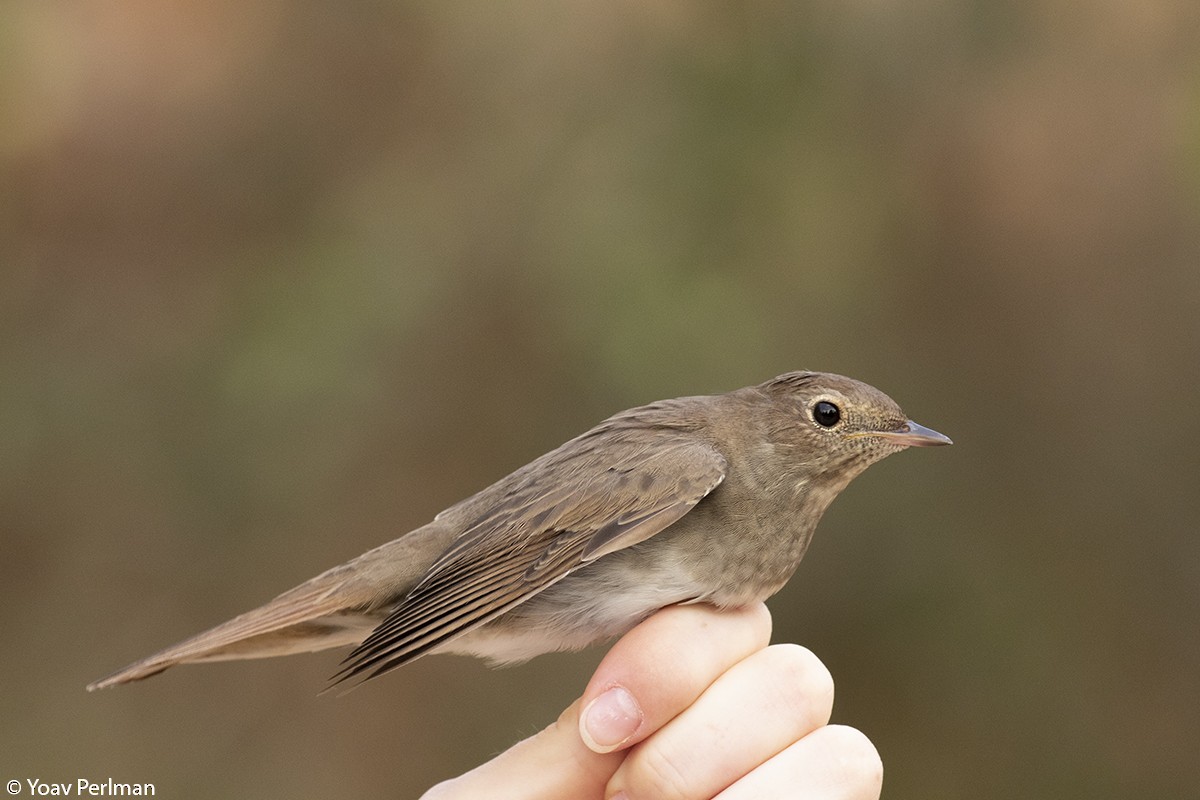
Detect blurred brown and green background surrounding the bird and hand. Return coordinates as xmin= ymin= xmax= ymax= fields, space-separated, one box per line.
xmin=0 ymin=0 xmax=1200 ymax=800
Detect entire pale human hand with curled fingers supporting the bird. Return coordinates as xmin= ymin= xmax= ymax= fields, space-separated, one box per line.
xmin=422 ymin=603 xmax=883 ymax=800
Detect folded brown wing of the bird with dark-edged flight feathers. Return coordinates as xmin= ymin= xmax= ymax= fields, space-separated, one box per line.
xmin=332 ymin=429 xmax=726 ymax=682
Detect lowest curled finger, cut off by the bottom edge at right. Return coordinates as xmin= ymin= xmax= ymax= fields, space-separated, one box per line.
xmin=715 ymin=724 xmax=883 ymax=800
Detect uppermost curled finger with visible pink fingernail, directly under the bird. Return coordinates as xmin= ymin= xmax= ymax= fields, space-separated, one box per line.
xmin=580 ymin=603 xmax=770 ymax=753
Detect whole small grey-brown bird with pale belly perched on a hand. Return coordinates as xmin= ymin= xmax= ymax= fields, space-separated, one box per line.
xmin=88 ymin=371 xmax=952 ymax=691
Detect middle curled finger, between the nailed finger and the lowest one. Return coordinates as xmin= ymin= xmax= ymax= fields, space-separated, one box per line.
xmin=605 ymin=644 xmax=833 ymax=800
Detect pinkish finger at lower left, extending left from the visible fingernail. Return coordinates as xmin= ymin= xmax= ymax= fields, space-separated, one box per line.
xmin=421 ymin=700 xmax=624 ymax=800
